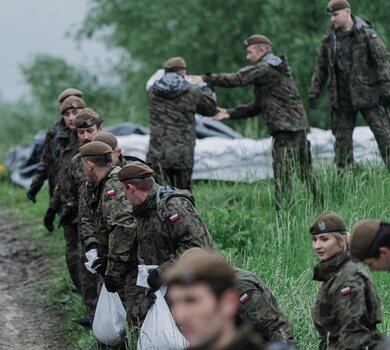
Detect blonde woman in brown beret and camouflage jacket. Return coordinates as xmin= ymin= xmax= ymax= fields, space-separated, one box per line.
xmin=310 ymin=211 xmax=383 ymax=350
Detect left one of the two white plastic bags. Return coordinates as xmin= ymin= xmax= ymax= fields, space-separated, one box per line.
xmin=92 ymin=283 xmax=126 ymax=345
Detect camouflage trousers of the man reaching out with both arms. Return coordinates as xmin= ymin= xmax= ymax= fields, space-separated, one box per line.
xmin=272 ymin=131 xmax=322 ymax=210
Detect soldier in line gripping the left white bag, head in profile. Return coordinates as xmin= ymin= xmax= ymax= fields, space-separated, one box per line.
xmin=80 ymin=141 xmax=144 ymax=325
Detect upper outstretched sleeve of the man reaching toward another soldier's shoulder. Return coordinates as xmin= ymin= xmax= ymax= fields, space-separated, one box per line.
xmin=202 ymin=64 xmax=269 ymax=88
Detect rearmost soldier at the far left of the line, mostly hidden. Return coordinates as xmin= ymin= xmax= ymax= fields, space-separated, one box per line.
xmin=27 ymin=88 xmax=83 ymax=203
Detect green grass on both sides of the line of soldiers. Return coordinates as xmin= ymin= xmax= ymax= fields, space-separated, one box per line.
xmin=0 ymin=163 xmax=390 ymax=349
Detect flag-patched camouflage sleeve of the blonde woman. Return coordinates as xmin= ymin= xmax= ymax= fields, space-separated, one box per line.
xmin=332 ymin=277 xmax=380 ymax=350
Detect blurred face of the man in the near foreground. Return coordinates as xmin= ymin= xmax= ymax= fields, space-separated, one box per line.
xmin=168 ymin=283 xmax=238 ymax=347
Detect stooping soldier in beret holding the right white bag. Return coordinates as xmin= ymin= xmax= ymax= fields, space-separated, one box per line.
xmin=118 ymin=161 xmax=213 ymax=300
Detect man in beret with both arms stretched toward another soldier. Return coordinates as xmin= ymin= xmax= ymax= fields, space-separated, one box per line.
xmin=193 ymin=35 xmax=321 ymax=209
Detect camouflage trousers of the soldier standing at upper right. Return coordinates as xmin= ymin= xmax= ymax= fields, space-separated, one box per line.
xmin=332 ymin=106 xmax=390 ymax=170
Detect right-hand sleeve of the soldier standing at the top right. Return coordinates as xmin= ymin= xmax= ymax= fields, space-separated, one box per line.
xmin=367 ymin=29 xmax=390 ymax=94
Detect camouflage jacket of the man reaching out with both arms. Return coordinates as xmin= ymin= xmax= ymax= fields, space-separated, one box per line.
xmin=203 ymin=53 xmax=308 ymax=135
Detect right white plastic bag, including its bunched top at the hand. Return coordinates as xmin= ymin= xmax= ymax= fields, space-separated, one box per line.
xmin=137 ymin=265 xmax=188 ymax=350
